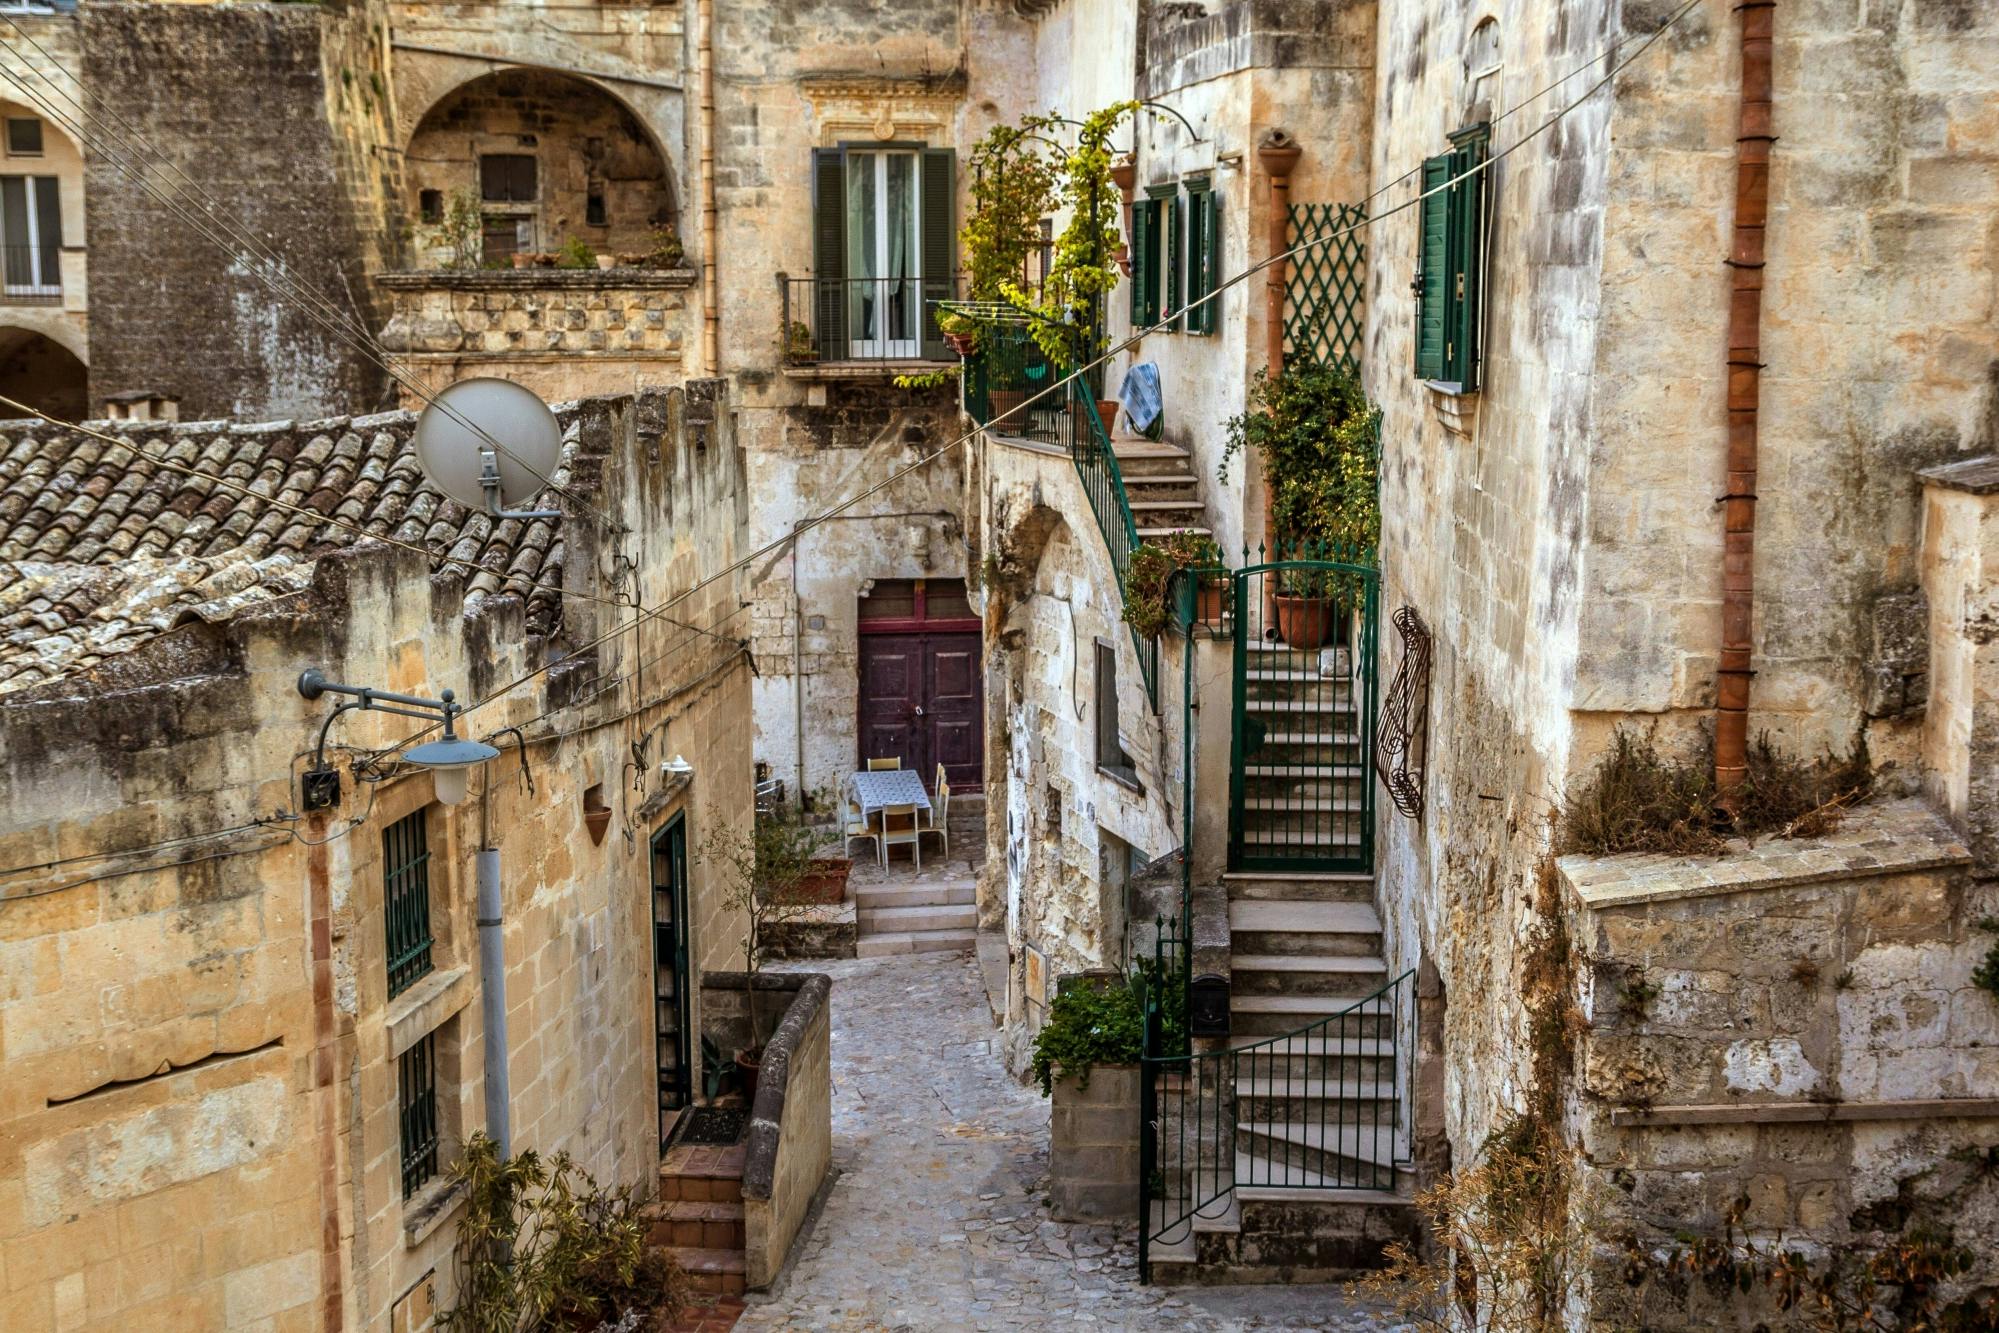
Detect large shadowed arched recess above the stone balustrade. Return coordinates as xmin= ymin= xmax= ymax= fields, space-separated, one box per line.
xmin=406 ymin=70 xmax=680 ymax=268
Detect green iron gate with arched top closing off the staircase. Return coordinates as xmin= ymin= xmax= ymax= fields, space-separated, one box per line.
xmin=1229 ymin=560 xmax=1381 ymax=871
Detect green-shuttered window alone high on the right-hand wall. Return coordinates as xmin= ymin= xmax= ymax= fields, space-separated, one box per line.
xmin=1411 ymin=124 xmax=1489 ymax=394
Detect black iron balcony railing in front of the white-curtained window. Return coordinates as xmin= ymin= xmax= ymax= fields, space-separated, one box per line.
xmin=780 ymin=278 xmax=958 ymax=366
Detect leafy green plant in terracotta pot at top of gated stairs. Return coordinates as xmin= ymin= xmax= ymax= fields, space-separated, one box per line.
xmin=1219 ymin=353 xmax=1381 ymax=652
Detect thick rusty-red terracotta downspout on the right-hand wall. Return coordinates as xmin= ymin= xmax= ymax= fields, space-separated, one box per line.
xmin=1715 ymin=0 xmax=1775 ymax=807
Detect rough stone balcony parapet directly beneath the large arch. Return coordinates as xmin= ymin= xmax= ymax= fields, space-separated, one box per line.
xmin=378 ymin=268 xmax=700 ymax=408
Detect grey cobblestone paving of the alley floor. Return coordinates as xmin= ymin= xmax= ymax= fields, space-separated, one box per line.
xmin=738 ymin=953 xmax=1415 ymax=1333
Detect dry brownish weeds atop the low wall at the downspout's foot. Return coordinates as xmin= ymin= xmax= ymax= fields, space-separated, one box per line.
xmin=1555 ymin=729 xmax=1873 ymax=855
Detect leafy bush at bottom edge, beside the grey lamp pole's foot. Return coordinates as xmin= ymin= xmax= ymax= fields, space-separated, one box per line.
xmin=438 ymin=1133 xmax=688 ymax=1333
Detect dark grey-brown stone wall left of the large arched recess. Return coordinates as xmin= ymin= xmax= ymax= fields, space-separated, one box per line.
xmin=78 ymin=4 xmax=394 ymax=420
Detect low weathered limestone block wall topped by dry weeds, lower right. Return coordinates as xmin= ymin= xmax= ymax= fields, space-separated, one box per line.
xmin=1559 ymin=801 xmax=1999 ymax=1327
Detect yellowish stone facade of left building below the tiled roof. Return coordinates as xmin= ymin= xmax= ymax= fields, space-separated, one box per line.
xmin=0 ymin=396 xmax=752 ymax=1329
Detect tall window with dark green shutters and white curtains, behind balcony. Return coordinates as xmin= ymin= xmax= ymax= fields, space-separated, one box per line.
xmin=812 ymin=144 xmax=958 ymax=362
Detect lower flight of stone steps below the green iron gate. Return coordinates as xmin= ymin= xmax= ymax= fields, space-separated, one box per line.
xmin=1149 ymin=873 xmax=1419 ymax=1283
